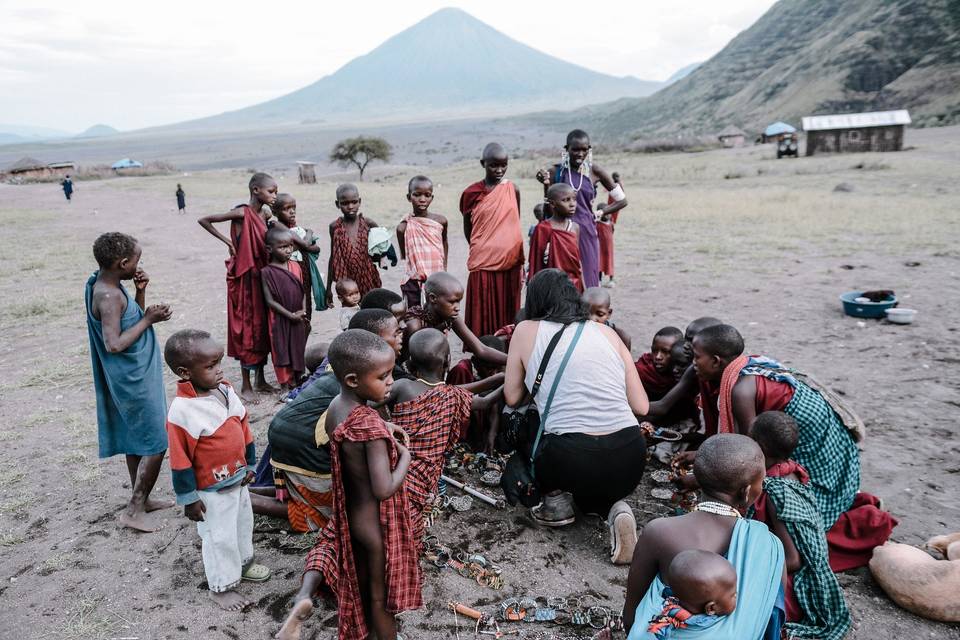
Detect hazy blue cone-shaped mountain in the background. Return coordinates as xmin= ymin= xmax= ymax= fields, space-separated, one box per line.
xmin=169 ymin=8 xmax=663 ymax=129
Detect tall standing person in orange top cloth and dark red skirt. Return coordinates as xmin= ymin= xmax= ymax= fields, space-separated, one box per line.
xmin=460 ymin=142 xmax=523 ymax=336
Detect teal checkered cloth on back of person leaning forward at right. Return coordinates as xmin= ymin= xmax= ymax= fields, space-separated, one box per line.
xmin=784 ymin=382 xmax=860 ymax=531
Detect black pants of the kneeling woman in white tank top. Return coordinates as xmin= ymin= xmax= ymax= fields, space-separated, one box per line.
xmin=534 ymin=425 xmax=647 ymax=517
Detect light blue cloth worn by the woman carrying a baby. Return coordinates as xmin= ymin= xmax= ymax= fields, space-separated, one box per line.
xmin=627 ymin=519 xmax=783 ymax=640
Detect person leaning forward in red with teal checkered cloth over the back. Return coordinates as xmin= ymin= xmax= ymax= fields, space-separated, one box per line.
xmin=693 ymin=324 xmax=860 ymax=529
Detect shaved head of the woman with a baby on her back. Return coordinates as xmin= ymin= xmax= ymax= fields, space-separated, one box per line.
xmin=693 ymin=433 xmax=766 ymax=496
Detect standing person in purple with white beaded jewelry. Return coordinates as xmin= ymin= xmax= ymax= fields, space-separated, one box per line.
xmin=537 ymin=129 xmax=627 ymax=288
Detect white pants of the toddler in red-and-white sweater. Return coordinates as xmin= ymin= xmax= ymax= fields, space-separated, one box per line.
xmin=197 ymin=484 xmax=253 ymax=593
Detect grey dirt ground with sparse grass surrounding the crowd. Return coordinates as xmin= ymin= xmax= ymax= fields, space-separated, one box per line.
xmin=0 ymin=128 xmax=960 ymax=640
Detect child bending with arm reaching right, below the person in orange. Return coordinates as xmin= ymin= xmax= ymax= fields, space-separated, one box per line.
xmin=403 ymin=271 xmax=507 ymax=365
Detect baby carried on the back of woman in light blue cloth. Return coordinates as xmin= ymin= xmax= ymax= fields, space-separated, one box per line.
xmin=647 ymin=549 xmax=737 ymax=640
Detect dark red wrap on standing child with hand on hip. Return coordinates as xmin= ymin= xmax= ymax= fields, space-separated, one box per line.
xmin=226 ymin=205 xmax=270 ymax=366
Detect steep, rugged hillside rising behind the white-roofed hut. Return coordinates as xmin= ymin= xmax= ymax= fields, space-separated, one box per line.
xmin=572 ymin=0 xmax=960 ymax=139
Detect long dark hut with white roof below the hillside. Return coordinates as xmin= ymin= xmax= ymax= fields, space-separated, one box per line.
xmin=803 ymin=109 xmax=910 ymax=156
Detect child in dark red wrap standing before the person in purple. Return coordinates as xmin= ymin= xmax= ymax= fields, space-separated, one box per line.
xmin=529 ymin=182 xmax=583 ymax=293
